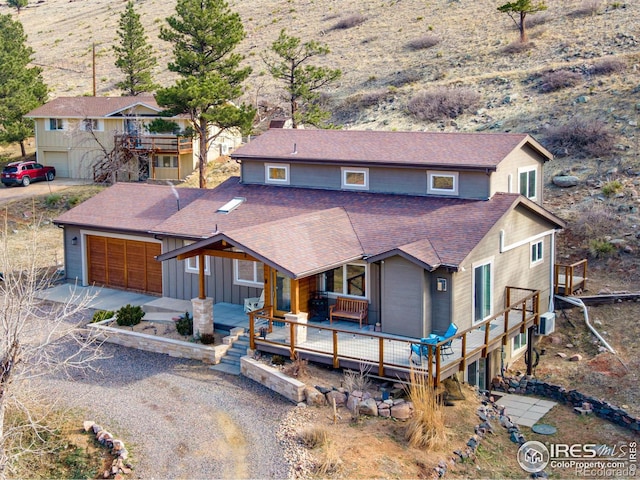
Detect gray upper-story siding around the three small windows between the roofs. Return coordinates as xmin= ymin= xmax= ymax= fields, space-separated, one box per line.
xmin=241 ymin=159 xmax=489 ymax=199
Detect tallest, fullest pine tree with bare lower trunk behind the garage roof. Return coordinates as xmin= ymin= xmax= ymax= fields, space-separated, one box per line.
xmin=156 ymin=0 xmax=255 ymax=188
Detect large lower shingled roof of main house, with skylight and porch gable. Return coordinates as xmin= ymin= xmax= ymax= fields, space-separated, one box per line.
xmin=56 ymin=177 xmax=562 ymax=278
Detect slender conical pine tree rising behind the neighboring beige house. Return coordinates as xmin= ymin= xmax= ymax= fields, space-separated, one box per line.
xmin=113 ymin=1 xmax=158 ymax=96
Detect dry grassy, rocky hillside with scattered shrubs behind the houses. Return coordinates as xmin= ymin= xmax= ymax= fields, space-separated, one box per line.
xmin=5 ymin=0 xmax=640 ymax=278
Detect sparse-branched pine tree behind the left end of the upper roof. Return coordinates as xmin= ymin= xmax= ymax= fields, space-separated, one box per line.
xmin=263 ymin=29 xmax=342 ymax=128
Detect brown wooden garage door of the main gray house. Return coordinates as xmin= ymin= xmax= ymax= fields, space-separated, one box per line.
xmin=87 ymin=235 xmax=162 ymax=294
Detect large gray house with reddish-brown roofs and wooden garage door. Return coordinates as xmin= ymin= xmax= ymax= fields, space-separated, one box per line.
xmin=55 ymin=129 xmax=564 ymax=388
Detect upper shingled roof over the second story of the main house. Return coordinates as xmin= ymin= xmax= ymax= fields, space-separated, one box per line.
xmin=231 ymin=128 xmax=552 ymax=170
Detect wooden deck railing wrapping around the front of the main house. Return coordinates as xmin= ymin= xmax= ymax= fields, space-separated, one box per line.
xmin=249 ymin=287 xmax=540 ymax=385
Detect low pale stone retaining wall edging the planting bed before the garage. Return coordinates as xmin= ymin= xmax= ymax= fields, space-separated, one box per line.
xmin=87 ymin=320 xmax=233 ymax=364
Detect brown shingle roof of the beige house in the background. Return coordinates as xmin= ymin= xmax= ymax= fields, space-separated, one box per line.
xmin=26 ymin=95 xmax=162 ymax=118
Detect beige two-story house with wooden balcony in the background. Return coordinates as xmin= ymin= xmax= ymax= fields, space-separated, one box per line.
xmin=26 ymin=96 xmax=241 ymax=181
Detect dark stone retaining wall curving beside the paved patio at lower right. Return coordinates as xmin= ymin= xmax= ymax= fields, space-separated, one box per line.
xmin=491 ymin=375 xmax=640 ymax=432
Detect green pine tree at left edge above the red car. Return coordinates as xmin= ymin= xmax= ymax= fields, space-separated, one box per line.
xmin=0 ymin=15 xmax=47 ymax=157
